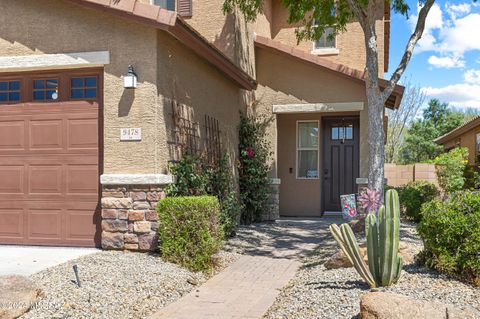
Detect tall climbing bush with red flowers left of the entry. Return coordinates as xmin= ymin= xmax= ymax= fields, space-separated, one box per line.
xmin=238 ymin=114 xmax=270 ymax=224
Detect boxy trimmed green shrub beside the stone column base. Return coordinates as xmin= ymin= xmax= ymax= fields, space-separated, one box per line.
xmin=158 ymin=196 xmax=223 ymax=272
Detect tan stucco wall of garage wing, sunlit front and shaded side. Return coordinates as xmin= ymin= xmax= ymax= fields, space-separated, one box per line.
xmin=0 ymin=0 xmax=246 ymax=173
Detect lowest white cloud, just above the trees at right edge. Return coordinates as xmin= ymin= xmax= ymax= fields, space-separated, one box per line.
xmin=423 ymin=84 xmax=480 ymax=108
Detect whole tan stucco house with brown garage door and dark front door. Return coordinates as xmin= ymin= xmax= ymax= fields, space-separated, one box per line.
xmin=0 ymin=0 xmax=403 ymax=250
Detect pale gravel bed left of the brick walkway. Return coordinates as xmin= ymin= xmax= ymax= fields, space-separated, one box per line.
xmin=21 ymin=251 xmax=238 ymax=319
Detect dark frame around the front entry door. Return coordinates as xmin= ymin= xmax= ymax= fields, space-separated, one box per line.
xmin=320 ymin=115 xmax=360 ymax=216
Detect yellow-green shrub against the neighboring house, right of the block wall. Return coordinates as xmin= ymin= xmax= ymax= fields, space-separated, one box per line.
xmin=435 ymin=147 xmax=468 ymax=194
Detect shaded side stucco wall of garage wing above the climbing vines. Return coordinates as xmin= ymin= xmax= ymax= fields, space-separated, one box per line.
xmin=157 ymin=32 xmax=246 ymax=174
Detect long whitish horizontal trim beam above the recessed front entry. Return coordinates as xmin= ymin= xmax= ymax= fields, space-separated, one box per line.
xmin=272 ymin=102 xmax=364 ymax=114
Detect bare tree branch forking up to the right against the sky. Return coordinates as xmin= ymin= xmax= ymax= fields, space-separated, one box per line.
xmin=382 ymin=0 xmax=435 ymax=101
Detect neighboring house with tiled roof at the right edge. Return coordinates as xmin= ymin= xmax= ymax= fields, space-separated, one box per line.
xmin=435 ymin=116 xmax=480 ymax=165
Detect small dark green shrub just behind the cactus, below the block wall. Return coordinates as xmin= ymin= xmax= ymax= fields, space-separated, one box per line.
xmin=398 ymin=181 xmax=438 ymax=223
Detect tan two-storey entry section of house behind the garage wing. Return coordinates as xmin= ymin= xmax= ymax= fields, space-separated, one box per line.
xmin=187 ymin=0 xmax=404 ymax=219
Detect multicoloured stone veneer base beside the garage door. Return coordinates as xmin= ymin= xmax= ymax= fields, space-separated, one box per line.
xmin=102 ymin=185 xmax=165 ymax=251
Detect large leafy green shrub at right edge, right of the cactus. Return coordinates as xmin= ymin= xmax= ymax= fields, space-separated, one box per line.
xmin=417 ymin=191 xmax=480 ymax=285
